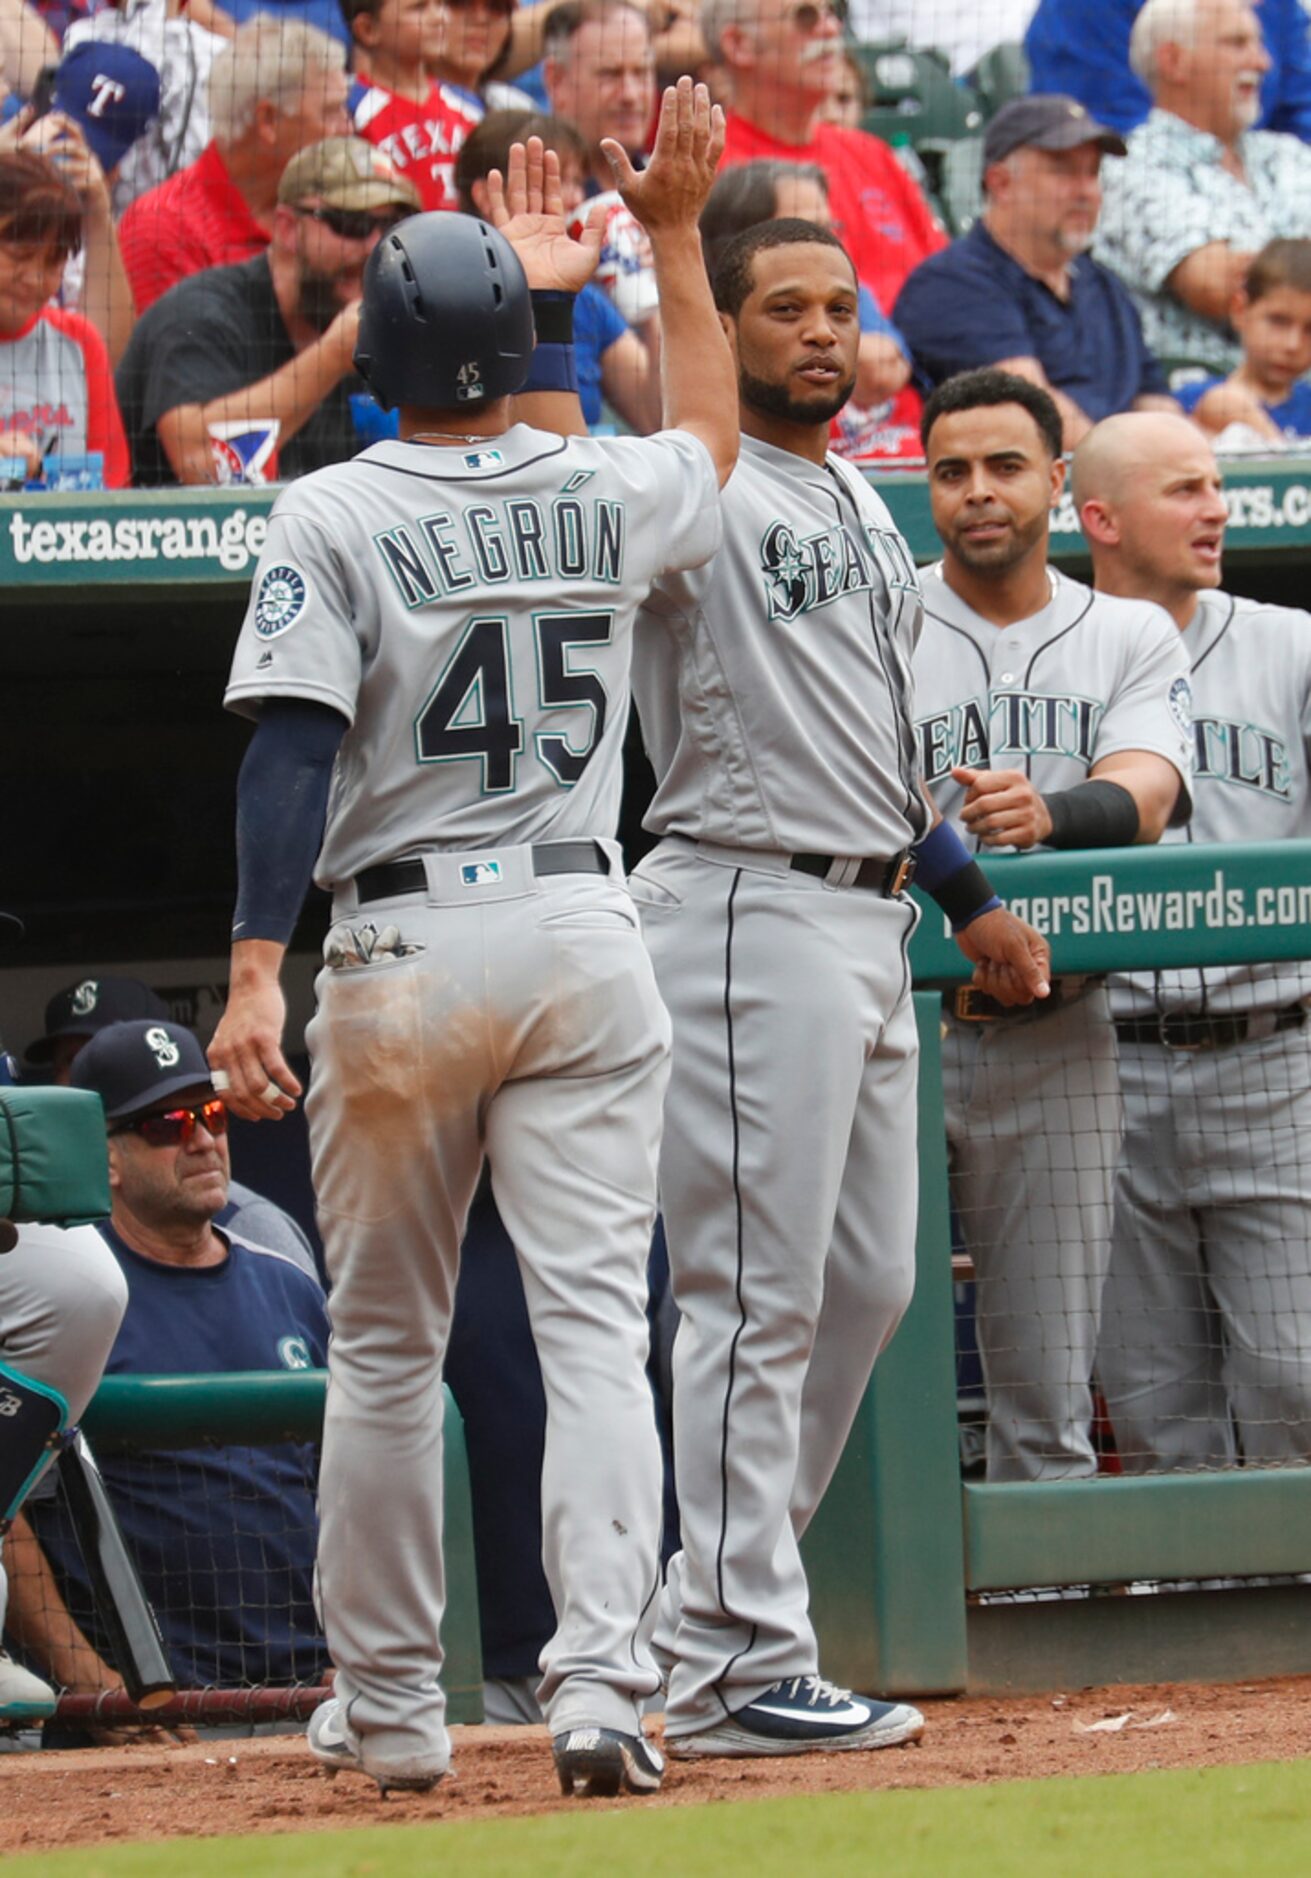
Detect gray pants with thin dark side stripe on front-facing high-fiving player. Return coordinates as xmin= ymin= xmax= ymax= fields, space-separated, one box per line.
xmin=633 ymin=843 xmax=917 ymax=1735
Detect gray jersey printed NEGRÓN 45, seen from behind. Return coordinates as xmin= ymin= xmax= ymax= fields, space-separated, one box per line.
xmin=227 ymin=424 xmax=719 ymax=888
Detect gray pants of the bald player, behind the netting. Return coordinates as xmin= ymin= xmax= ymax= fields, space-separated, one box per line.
xmin=1097 ymin=1020 xmax=1311 ymax=1474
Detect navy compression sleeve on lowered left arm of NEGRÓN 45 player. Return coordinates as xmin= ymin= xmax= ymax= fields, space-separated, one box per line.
xmin=233 ymin=699 xmax=346 ymax=945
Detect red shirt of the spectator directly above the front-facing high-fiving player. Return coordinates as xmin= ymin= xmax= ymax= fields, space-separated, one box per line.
xmin=723 ymin=111 xmax=947 ymax=306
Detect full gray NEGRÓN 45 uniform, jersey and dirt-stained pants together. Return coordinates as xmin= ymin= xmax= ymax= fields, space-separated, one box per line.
xmin=227 ymin=426 xmax=719 ymax=1778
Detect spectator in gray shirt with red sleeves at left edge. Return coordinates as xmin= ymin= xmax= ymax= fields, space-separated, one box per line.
xmin=0 ymin=150 xmax=128 ymax=488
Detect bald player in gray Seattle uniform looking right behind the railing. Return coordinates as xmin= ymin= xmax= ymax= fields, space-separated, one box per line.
xmin=1072 ymin=413 xmax=1311 ymax=1472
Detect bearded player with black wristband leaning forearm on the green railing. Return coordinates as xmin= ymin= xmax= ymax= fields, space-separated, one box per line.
xmin=915 ymin=370 xmax=1191 ymax=1480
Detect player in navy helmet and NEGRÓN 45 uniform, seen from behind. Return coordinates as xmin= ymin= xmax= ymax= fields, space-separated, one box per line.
xmin=210 ymin=91 xmax=738 ymax=1793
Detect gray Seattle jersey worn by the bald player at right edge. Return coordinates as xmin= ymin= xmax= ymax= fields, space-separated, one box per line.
xmin=1110 ymin=593 xmax=1311 ymax=1016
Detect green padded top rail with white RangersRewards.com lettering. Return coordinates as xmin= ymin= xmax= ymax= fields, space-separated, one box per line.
xmin=911 ymin=841 xmax=1311 ymax=982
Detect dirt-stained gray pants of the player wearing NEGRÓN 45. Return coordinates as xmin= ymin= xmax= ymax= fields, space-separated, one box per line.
xmin=306 ymin=847 xmax=669 ymax=1775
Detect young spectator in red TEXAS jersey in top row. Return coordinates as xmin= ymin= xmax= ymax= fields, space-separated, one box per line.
xmin=342 ymin=0 xmax=483 ymax=208
